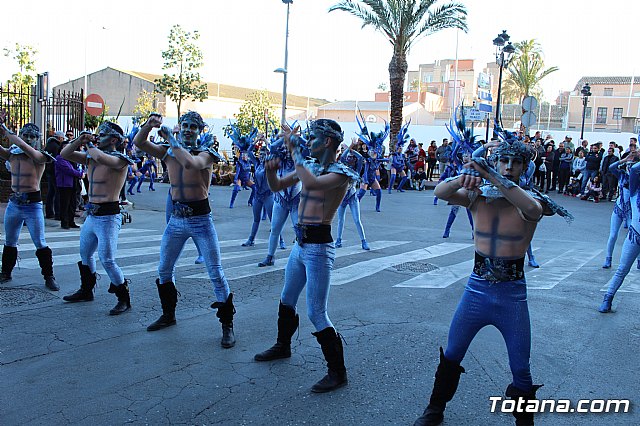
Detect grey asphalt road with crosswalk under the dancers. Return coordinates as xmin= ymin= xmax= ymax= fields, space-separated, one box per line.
xmin=0 ymin=184 xmax=640 ymax=425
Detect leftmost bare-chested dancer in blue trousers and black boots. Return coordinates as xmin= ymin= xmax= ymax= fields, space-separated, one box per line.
xmin=0 ymin=115 xmax=60 ymax=291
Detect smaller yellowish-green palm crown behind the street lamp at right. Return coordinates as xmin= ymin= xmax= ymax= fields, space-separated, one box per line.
xmin=503 ymin=39 xmax=558 ymax=103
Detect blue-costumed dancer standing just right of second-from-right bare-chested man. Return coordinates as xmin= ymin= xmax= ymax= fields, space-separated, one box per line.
xmin=336 ymin=138 xmax=371 ymax=250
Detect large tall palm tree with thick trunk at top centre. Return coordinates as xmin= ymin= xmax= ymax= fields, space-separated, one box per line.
xmin=329 ymin=0 xmax=467 ymax=145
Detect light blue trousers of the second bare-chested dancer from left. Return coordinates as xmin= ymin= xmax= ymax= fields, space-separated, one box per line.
xmin=80 ymin=214 xmax=124 ymax=285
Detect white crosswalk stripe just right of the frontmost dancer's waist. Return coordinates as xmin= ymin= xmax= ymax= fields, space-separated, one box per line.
xmin=526 ymin=249 xmax=602 ymax=290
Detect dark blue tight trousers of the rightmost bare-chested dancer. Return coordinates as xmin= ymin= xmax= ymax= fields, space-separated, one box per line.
xmin=445 ymin=273 xmax=533 ymax=391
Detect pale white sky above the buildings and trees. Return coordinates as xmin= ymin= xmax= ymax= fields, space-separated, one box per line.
xmin=0 ymin=0 xmax=640 ymax=101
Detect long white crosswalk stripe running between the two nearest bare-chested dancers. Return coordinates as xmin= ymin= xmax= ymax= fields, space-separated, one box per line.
xmin=331 ymin=243 xmax=473 ymax=285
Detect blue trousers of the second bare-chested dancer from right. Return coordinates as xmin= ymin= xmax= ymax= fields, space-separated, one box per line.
xmin=276 ymin=243 xmax=336 ymax=331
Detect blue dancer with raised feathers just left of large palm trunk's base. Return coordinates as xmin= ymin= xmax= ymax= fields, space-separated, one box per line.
xmin=356 ymin=112 xmax=389 ymax=212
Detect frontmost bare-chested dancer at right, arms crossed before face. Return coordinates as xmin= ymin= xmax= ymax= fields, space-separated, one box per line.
xmin=414 ymin=125 xmax=572 ymax=426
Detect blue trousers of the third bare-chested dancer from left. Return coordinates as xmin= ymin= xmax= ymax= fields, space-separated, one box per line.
xmin=158 ymin=213 xmax=229 ymax=302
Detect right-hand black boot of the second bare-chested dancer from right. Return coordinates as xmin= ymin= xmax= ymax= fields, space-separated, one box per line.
xmin=311 ymin=327 xmax=348 ymax=393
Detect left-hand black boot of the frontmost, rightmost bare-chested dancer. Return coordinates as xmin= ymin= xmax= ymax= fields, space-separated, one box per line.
xmin=413 ymin=348 xmax=464 ymax=426
